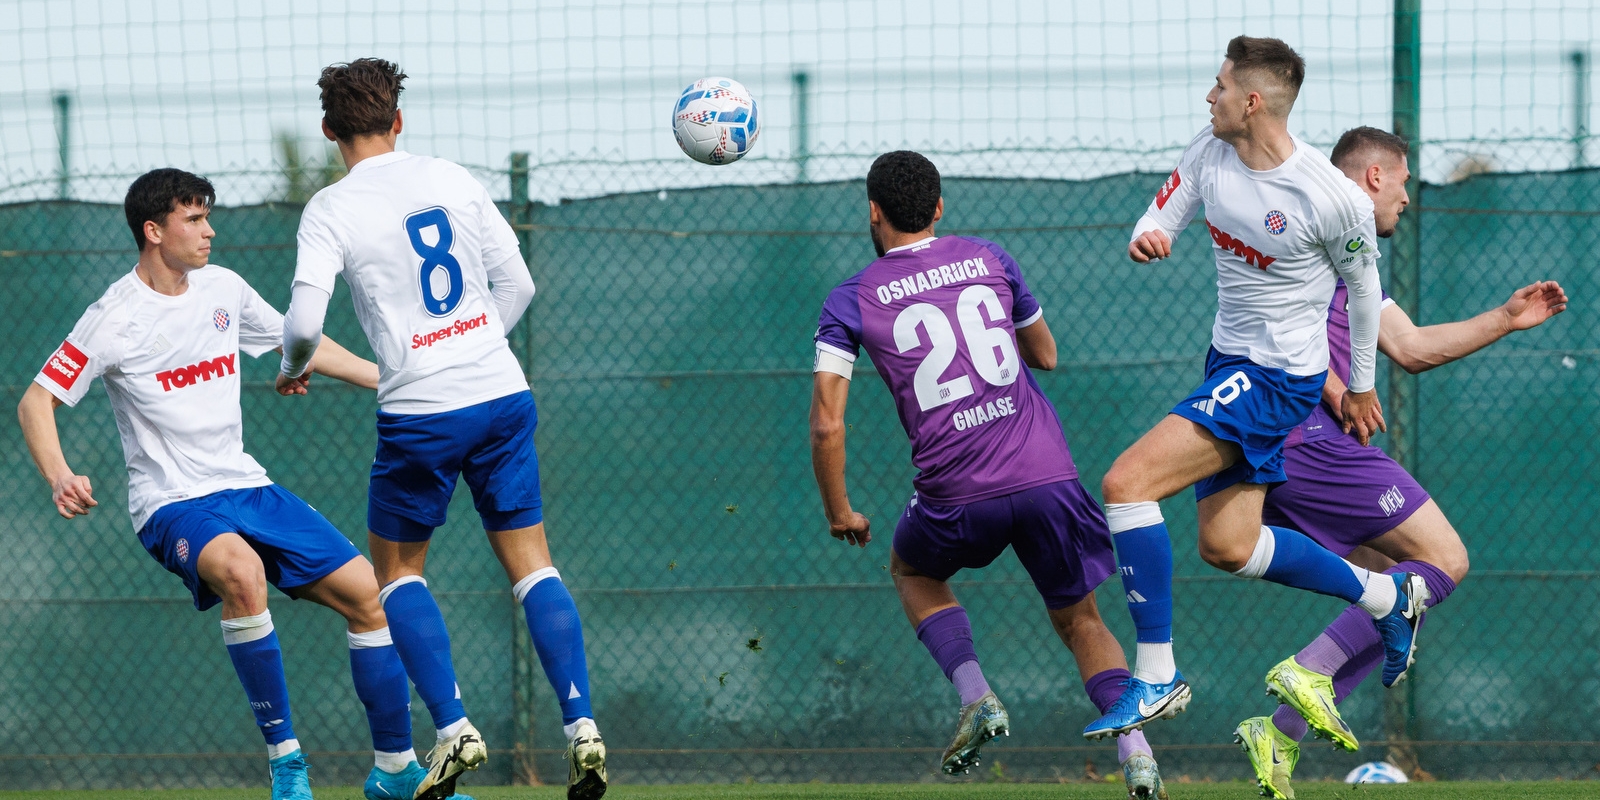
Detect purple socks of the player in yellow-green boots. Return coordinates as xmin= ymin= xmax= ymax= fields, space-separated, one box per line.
xmin=1272 ymin=562 xmax=1456 ymax=741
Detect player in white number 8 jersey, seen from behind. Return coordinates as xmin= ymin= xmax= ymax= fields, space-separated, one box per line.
xmin=278 ymin=58 xmax=606 ymax=800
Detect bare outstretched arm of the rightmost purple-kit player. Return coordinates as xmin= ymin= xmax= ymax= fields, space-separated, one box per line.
xmin=1378 ymin=280 xmax=1566 ymax=374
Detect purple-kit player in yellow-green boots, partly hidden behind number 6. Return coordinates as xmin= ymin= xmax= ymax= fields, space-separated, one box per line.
xmin=1235 ymin=128 xmax=1566 ymax=798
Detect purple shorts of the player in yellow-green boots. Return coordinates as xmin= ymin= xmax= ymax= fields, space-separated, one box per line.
xmin=1261 ymin=435 xmax=1427 ymax=557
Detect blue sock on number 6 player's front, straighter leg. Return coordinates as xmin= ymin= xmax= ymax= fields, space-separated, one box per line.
xmin=1106 ymin=502 xmax=1173 ymax=643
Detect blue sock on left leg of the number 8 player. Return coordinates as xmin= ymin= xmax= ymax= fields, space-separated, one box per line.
xmin=378 ymin=574 xmax=467 ymax=728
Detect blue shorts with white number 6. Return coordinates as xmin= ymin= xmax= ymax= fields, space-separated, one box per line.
xmin=1171 ymin=347 xmax=1328 ymax=501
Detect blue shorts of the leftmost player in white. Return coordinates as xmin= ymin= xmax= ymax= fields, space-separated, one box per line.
xmin=139 ymin=483 xmax=362 ymax=611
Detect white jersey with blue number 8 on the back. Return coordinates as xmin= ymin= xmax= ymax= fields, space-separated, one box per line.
xmin=294 ymin=152 xmax=528 ymax=414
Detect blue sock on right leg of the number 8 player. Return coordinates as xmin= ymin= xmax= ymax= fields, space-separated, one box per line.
xmin=512 ymin=566 xmax=594 ymax=736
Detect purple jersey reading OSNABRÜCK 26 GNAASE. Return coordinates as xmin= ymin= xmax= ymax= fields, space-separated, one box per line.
xmin=816 ymin=237 xmax=1078 ymax=506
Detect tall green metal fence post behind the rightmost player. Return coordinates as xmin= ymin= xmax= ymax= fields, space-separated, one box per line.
xmin=1384 ymin=0 xmax=1426 ymax=776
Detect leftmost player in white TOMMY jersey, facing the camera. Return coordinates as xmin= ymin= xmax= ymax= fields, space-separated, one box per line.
xmin=18 ymin=170 xmax=438 ymax=800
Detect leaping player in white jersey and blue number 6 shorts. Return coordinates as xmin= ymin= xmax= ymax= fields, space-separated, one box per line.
xmin=1083 ymin=37 xmax=1427 ymax=738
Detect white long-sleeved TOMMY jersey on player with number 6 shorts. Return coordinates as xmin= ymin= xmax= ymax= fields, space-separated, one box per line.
xmin=1133 ymin=126 xmax=1379 ymax=390
